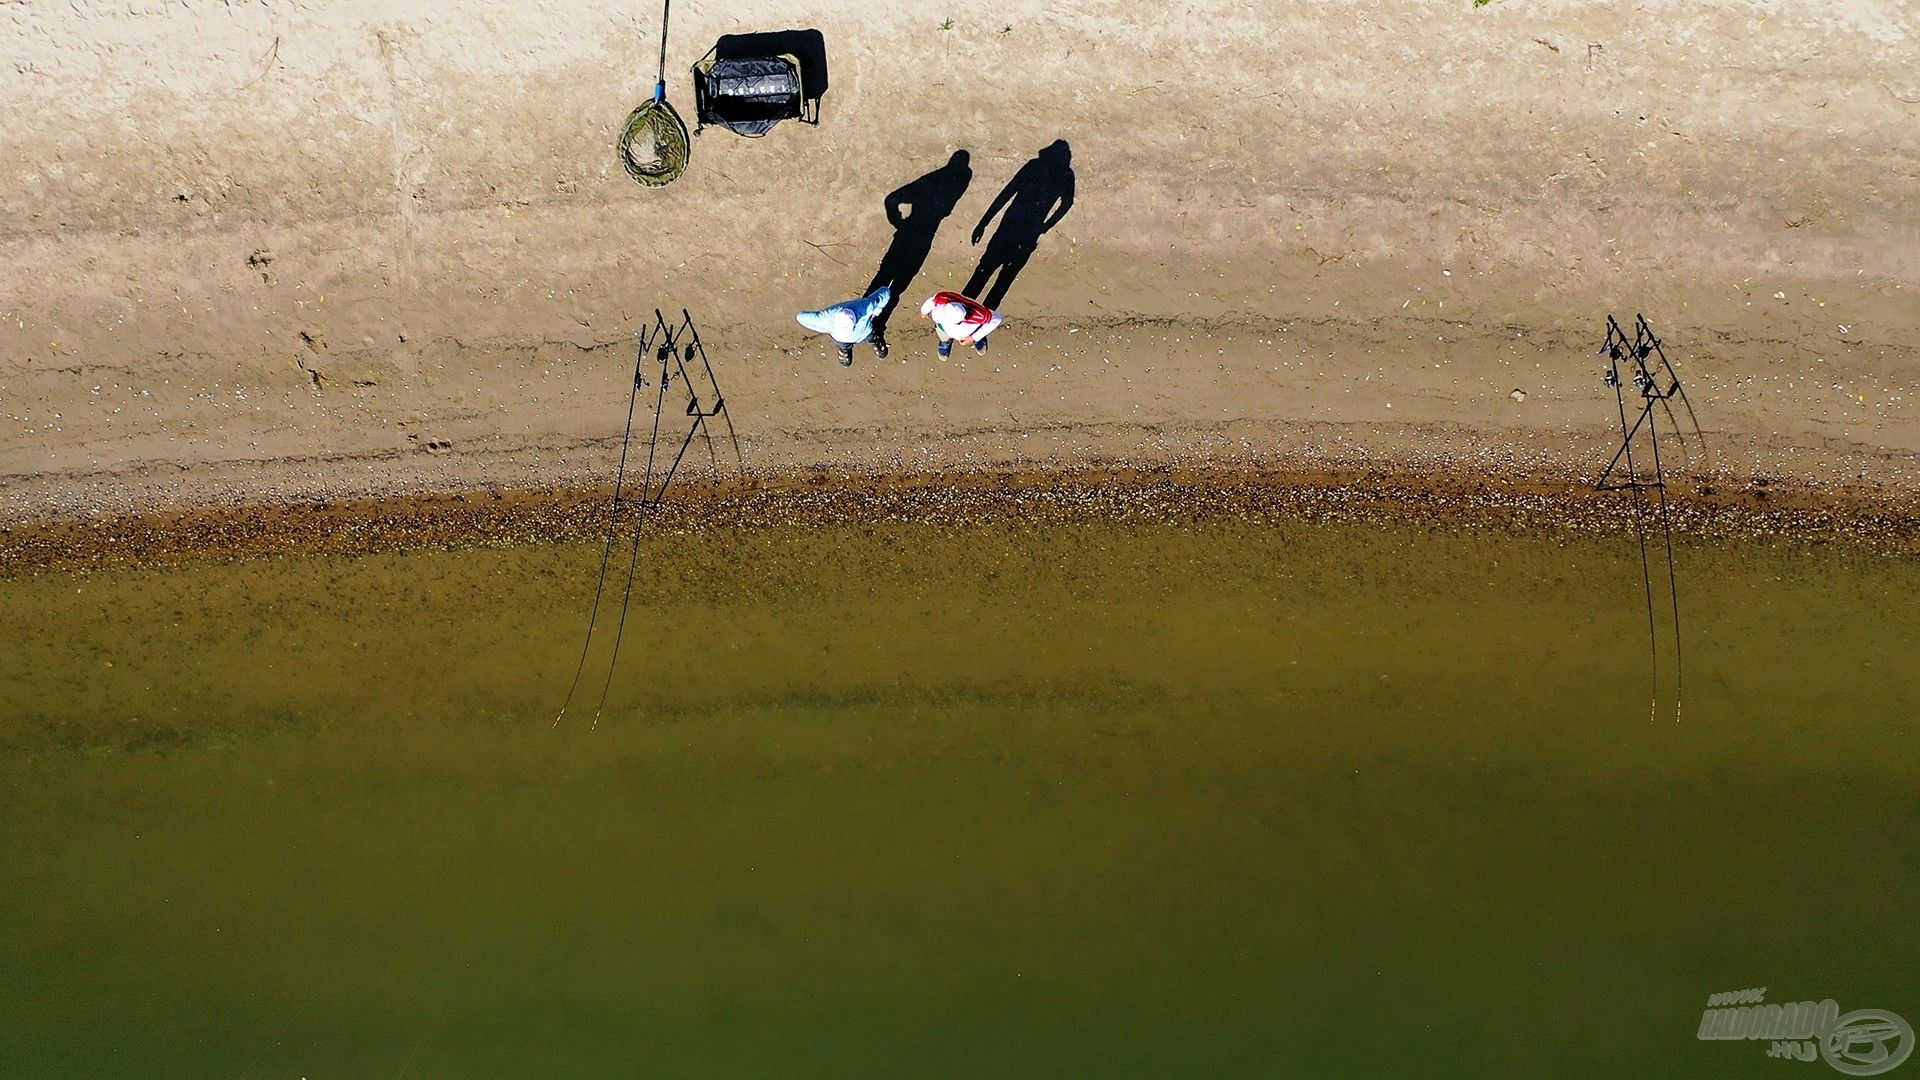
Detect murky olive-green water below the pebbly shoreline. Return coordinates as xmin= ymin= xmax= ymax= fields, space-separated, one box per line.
xmin=0 ymin=521 xmax=1920 ymax=1080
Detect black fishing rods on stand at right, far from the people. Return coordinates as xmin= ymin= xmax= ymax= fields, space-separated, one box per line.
xmin=1594 ymin=315 xmax=1707 ymax=723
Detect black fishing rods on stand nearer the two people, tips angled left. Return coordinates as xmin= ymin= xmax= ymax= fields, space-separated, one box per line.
xmin=553 ymin=307 xmax=745 ymax=726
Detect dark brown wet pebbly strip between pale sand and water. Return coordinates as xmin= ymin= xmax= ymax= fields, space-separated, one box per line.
xmin=0 ymin=467 xmax=1920 ymax=578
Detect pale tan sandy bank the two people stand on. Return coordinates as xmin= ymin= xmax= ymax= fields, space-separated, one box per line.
xmin=0 ymin=0 xmax=1920 ymax=548
